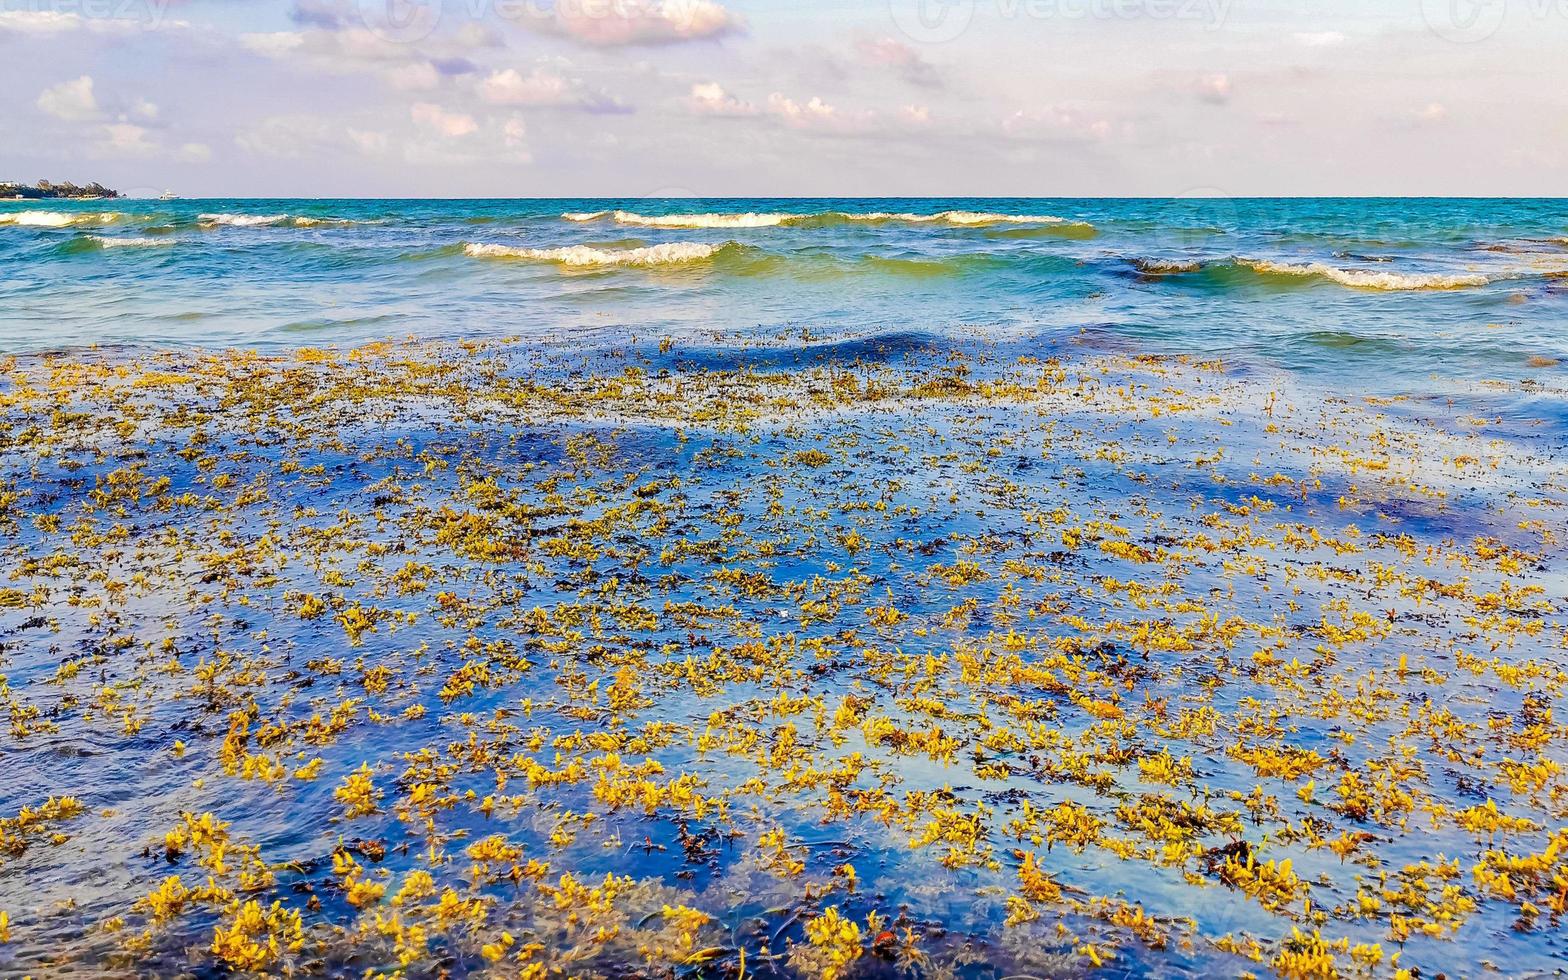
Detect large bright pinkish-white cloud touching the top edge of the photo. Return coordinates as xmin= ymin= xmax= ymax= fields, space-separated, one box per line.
xmin=532 ymin=0 xmax=745 ymax=47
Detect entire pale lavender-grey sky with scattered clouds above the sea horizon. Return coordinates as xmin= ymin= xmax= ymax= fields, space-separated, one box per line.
xmin=0 ymin=0 xmax=1568 ymax=198
